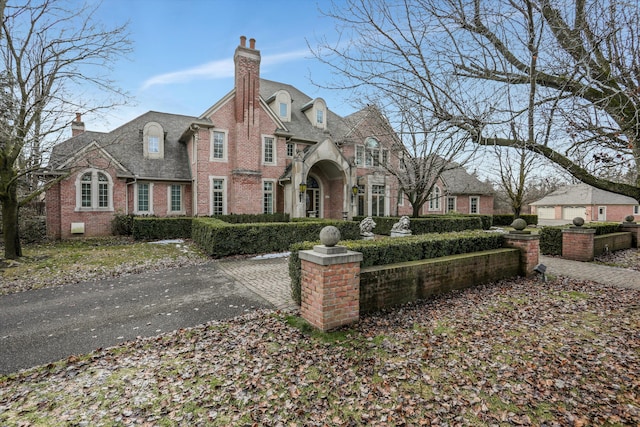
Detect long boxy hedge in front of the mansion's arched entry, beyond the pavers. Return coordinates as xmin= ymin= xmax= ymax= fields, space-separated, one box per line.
xmin=192 ymin=218 xmax=360 ymax=258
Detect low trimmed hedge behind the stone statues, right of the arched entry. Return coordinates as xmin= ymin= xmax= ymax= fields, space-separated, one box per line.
xmin=353 ymin=215 xmax=491 ymax=236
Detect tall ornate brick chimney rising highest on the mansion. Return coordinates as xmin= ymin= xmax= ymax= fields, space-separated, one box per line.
xmin=233 ymin=36 xmax=260 ymax=125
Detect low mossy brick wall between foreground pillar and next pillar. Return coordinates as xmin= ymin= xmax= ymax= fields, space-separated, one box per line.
xmin=360 ymin=248 xmax=520 ymax=314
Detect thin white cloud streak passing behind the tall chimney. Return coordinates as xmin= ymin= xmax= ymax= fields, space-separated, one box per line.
xmin=141 ymin=50 xmax=309 ymax=90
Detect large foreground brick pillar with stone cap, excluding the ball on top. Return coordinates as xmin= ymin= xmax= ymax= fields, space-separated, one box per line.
xmin=299 ymin=245 xmax=362 ymax=331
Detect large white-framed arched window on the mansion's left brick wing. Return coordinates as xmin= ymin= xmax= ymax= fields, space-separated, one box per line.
xmin=76 ymin=170 xmax=113 ymax=211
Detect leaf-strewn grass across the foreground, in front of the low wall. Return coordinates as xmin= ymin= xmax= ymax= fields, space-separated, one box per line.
xmin=0 ymin=278 xmax=640 ymax=426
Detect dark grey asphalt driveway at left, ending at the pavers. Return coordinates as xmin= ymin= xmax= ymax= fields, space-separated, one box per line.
xmin=0 ymin=261 xmax=273 ymax=374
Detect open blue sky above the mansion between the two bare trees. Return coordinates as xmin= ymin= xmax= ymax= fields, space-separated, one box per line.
xmin=88 ymin=0 xmax=353 ymax=131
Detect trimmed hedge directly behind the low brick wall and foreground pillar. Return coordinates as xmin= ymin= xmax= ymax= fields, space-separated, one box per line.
xmin=289 ymin=231 xmax=504 ymax=305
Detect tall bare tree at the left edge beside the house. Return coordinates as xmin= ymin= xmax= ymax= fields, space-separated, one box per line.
xmin=0 ymin=0 xmax=130 ymax=259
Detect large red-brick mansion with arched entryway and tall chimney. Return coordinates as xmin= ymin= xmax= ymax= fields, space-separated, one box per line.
xmin=46 ymin=37 xmax=492 ymax=238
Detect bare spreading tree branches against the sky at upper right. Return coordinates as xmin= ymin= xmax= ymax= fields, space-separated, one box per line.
xmin=316 ymin=0 xmax=640 ymax=204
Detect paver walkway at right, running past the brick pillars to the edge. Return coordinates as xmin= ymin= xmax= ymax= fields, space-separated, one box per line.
xmin=540 ymin=255 xmax=640 ymax=289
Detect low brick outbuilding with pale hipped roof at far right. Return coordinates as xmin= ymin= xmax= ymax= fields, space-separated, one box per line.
xmin=531 ymin=184 xmax=640 ymax=224
